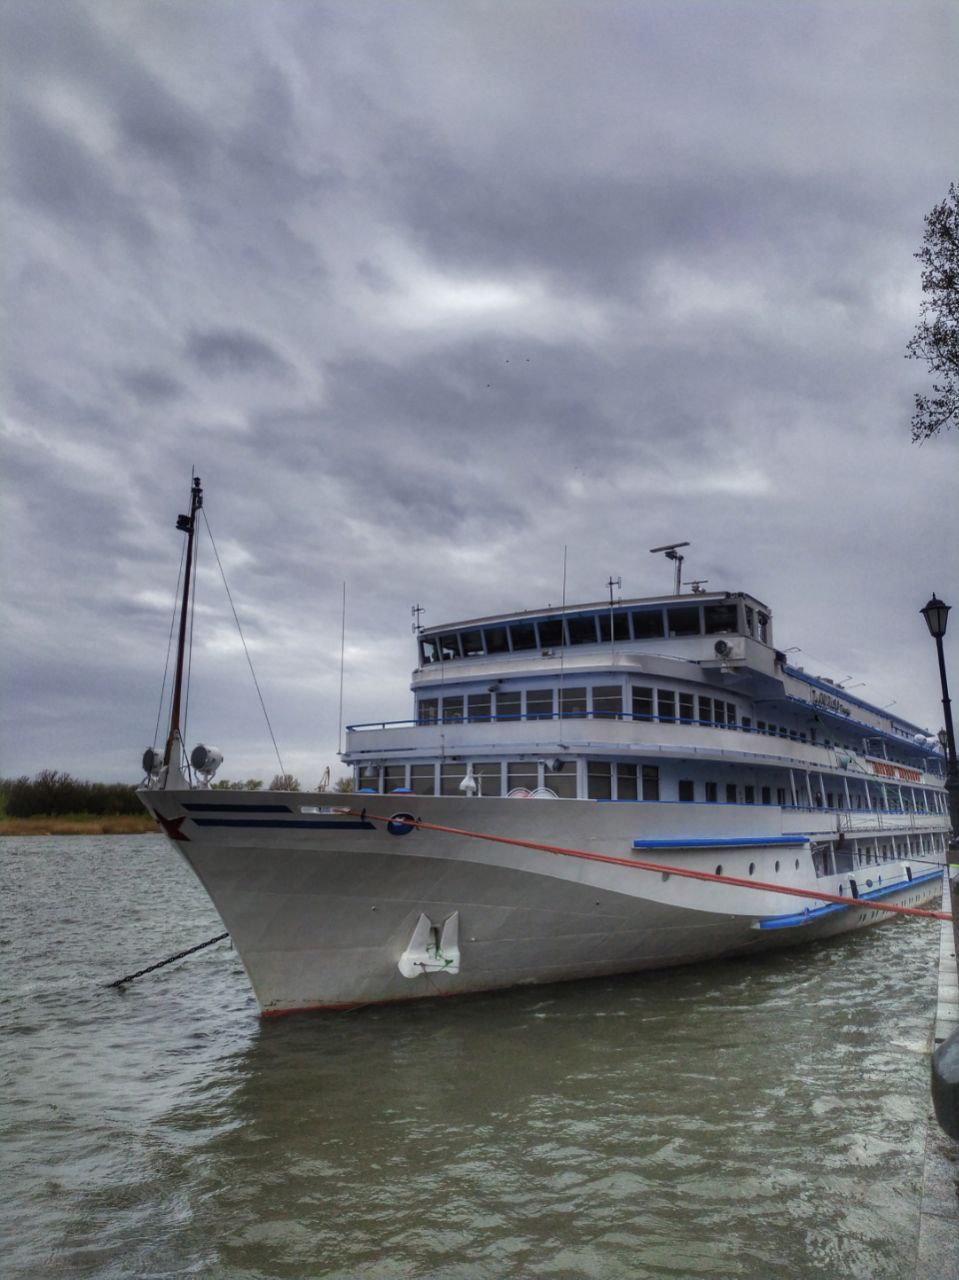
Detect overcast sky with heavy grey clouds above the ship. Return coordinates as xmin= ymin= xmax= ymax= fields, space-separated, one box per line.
xmin=0 ymin=0 xmax=959 ymax=785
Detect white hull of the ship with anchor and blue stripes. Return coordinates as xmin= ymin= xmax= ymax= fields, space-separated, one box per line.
xmin=141 ymin=790 xmax=941 ymax=1015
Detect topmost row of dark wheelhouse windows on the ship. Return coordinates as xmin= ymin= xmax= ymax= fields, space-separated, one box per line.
xmin=420 ymin=602 xmax=770 ymax=664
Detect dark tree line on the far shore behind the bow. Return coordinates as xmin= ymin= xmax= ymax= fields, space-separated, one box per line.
xmin=0 ymin=769 xmax=353 ymax=818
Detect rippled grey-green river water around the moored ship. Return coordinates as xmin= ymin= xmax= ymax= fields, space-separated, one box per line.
xmin=0 ymin=836 xmax=939 ymax=1280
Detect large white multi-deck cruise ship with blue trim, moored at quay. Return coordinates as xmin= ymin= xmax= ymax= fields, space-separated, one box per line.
xmin=141 ymin=483 xmax=949 ymax=1015
